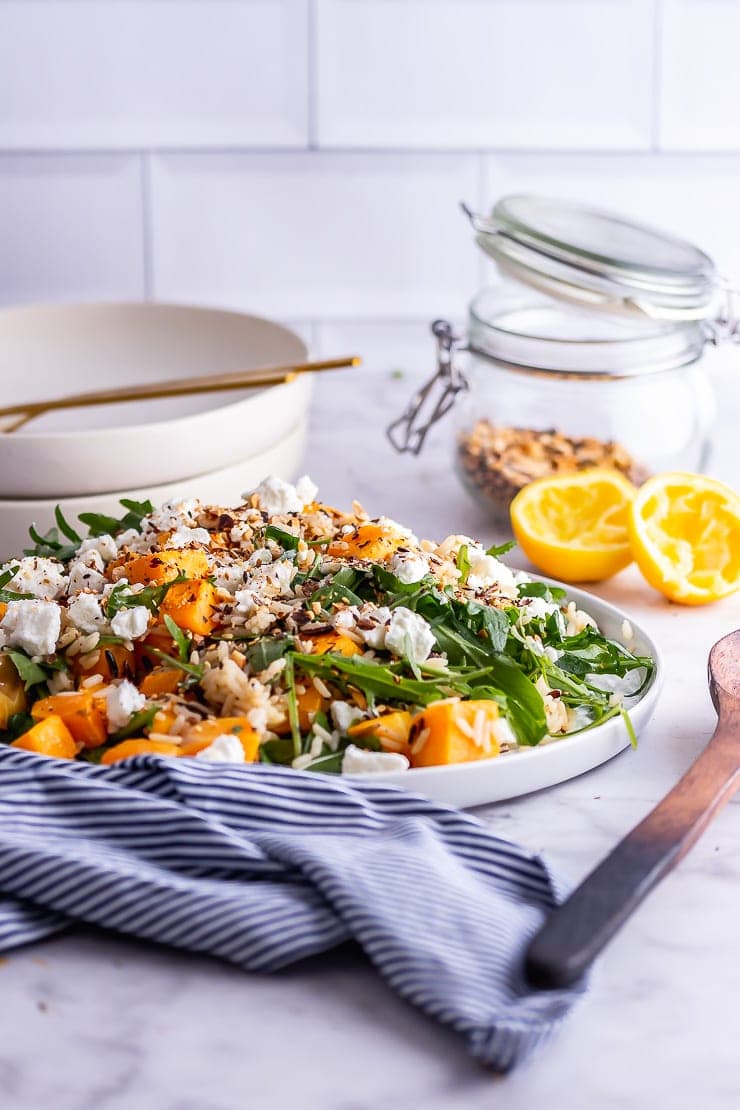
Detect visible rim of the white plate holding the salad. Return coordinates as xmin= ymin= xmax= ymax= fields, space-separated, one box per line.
xmin=347 ymin=578 xmax=663 ymax=809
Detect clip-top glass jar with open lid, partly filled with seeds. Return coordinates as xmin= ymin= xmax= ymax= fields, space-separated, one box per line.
xmin=388 ymin=196 xmax=733 ymax=523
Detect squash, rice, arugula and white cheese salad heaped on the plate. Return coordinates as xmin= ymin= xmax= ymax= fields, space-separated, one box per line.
xmin=0 ymin=477 xmax=653 ymax=775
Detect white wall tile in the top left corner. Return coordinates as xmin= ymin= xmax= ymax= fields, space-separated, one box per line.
xmin=0 ymin=0 xmax=308 ymax=149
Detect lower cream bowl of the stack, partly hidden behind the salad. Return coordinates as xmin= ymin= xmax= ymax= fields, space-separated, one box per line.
xmin=0 ymin=420 xmax=306 ymax=563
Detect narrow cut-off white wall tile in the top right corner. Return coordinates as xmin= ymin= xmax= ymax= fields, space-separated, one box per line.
xmin=660 ymin=0 xmax=740 ymax=150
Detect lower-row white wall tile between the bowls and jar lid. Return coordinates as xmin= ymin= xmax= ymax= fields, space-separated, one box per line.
xmin=152 ymin=153 xmax=479 ymax=317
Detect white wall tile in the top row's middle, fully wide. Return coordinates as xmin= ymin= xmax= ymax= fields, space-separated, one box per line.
xmin=316 ymin=0 xmax=653 ymax=150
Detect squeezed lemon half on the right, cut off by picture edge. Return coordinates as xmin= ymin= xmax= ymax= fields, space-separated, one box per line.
xmin=629 ymin=474 xmax=740 ymax=605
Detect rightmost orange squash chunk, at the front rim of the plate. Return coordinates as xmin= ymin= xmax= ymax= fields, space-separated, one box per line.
xmin=409 ymin=698 xmax=500 ymax=767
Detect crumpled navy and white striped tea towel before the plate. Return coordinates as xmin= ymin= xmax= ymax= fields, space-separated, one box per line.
xmin=0 ymin=745 xmax=582 ymax=1071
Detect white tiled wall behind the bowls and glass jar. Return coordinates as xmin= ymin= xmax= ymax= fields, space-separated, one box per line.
xmin=0 ymin=0 xmax=740 ymax=368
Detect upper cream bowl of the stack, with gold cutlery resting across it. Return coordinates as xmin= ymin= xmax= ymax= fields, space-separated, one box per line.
xmin=0 ymin=304 xmax=311 ymax=498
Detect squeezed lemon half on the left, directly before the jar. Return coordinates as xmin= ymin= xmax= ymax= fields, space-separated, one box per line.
xmin=511 ymin=470 xmax=635 ymax=582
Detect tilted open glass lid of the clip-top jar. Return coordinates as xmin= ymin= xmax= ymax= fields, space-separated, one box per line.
xmin=466 ymin=195 xmax=719 ymax=321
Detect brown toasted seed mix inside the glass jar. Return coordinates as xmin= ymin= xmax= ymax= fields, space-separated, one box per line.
xmin=457 ymin=420 xmax=649 ymax=513
